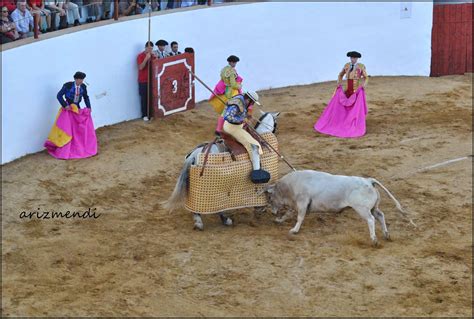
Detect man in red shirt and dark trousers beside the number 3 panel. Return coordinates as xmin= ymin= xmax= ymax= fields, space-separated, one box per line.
xmin=137 ymin=41 xmax=157 ymax=122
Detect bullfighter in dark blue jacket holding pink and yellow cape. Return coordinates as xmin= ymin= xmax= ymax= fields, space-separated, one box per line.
xmin=44 ymin=72 xmax=97 ymax=159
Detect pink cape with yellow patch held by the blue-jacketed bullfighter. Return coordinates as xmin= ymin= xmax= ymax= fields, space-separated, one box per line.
xmin=44 ymin=107 xmax=97 ymax=159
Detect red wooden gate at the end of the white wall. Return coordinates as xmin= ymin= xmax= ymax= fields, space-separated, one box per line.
xmin=430 ymin=3 xmax=473 ymax=76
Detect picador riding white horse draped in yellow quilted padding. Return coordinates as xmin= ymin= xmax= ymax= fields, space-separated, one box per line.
xmin=164 ymin=84 xmax=279 ymax=230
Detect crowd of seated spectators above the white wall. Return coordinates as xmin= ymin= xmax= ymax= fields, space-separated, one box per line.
xmin=0 ymin=0 xmax=226 ymax=44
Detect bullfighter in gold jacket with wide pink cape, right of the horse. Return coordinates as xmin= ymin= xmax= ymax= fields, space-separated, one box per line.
xmin=314 ymin=51 xmax=369 ymax=138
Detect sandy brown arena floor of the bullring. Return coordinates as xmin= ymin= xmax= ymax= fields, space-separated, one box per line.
xmin=2 ymin=75 xmax=472 ymax=316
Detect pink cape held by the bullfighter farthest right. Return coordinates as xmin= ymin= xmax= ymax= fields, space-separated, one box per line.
xmin=314 ymin=86 xmax=367 ymax=137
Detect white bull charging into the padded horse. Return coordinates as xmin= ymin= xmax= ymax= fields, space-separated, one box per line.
xmin=265 ymin=170 xmax=415 ymax=245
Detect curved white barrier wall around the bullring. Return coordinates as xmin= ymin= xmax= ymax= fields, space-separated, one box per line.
xmin=2 ymin=2 xmax=432 ymax=163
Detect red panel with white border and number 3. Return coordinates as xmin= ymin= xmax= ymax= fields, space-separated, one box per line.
xmin=152 ymin=53 xmax=195 ymax=117
